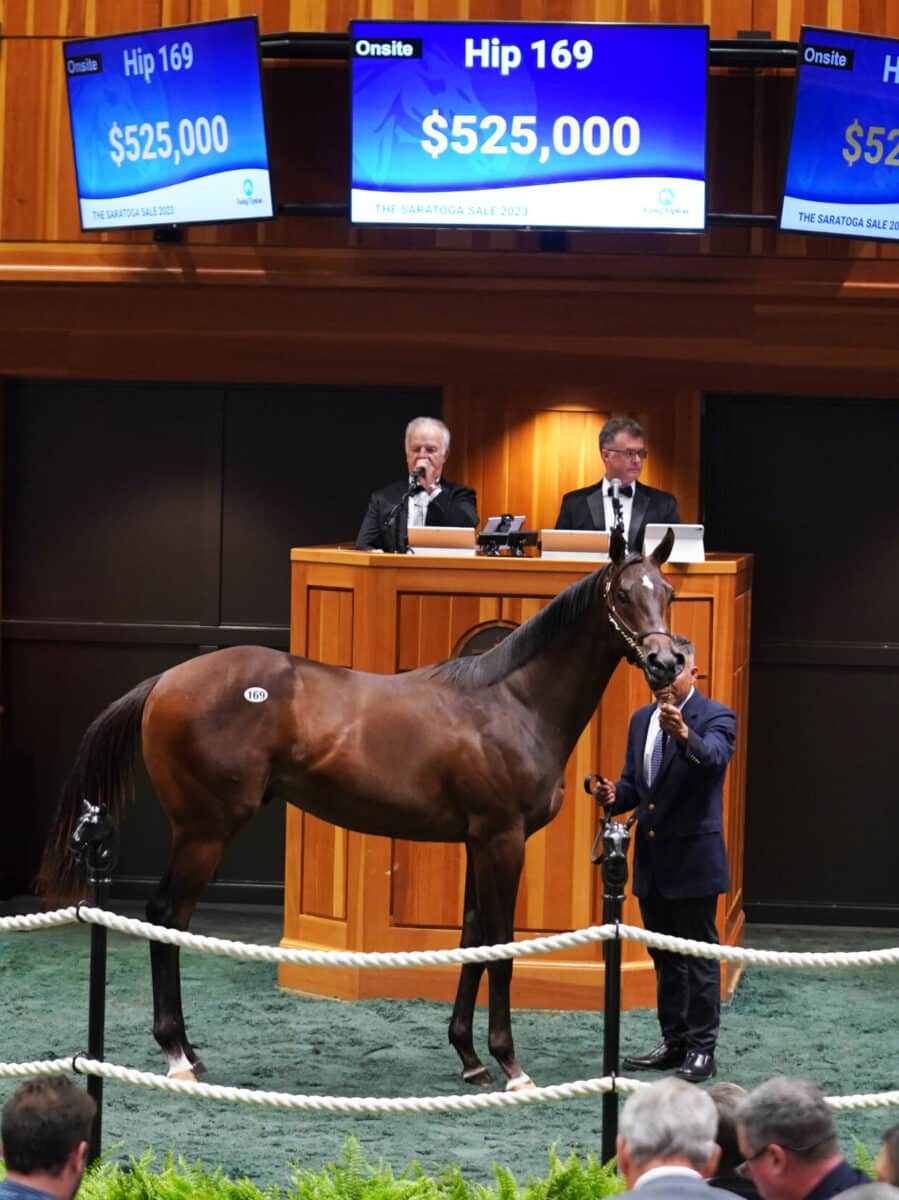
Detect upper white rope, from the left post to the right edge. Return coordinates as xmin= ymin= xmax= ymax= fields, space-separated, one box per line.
xmin=60 ymin=904 xmax=899 ymax=967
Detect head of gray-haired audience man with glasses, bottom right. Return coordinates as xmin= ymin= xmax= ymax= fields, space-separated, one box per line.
xmin=737 ymin=1075 xmax=840 ymax=1200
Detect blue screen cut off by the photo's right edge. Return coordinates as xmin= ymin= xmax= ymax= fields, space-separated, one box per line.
xmin=780 ymin=26 xmax=899 ymax=240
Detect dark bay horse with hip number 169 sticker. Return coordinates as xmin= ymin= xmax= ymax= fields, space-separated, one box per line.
xmin=41 ymin=530 xmax=683 ymax=1087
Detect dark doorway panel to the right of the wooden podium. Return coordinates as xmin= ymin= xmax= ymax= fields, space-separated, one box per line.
xmin=702 ymin=396 xmax=899 ymax=925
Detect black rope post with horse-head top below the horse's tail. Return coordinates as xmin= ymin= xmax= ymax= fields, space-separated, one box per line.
xmin=71 ymin=799 xmax=119 ymax=1163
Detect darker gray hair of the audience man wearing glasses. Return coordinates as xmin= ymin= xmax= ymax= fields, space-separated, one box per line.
xmin=737 ymin=1075 xmax=839 ymax=1163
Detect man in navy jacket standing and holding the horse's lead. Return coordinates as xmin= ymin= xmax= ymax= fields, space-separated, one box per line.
xmin=593 ymin=636 xmax=737 ymax=1084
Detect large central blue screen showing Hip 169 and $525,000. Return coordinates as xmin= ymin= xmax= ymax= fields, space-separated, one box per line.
xmin=349 ymin=20 xmax=708 ymax=230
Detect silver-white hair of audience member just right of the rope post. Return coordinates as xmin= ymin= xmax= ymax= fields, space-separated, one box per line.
xmin=619 ymin=1076 xmax=718 ymax=1170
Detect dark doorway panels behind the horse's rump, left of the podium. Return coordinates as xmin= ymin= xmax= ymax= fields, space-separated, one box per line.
xmin=0 ymin=382 xmax=440 ymax=902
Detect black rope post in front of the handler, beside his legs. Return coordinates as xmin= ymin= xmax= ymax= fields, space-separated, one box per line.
xmin=583 ymin=775 xmax=631 ymax=1163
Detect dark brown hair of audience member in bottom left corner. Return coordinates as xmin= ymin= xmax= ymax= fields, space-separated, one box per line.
xmin=0 ymin=1075 xmax=97 ymax=1175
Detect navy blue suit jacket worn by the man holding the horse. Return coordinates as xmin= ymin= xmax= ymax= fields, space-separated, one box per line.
xmin=612 ymin=689 xmax=737 ymax=900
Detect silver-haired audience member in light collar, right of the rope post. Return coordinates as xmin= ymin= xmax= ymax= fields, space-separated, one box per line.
xmin=617 ymin=1079 xmax=720 ymax=1200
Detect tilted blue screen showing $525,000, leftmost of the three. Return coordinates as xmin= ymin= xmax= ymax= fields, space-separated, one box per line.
xmin=62 ymin=17 xmax=274 ymax=230
